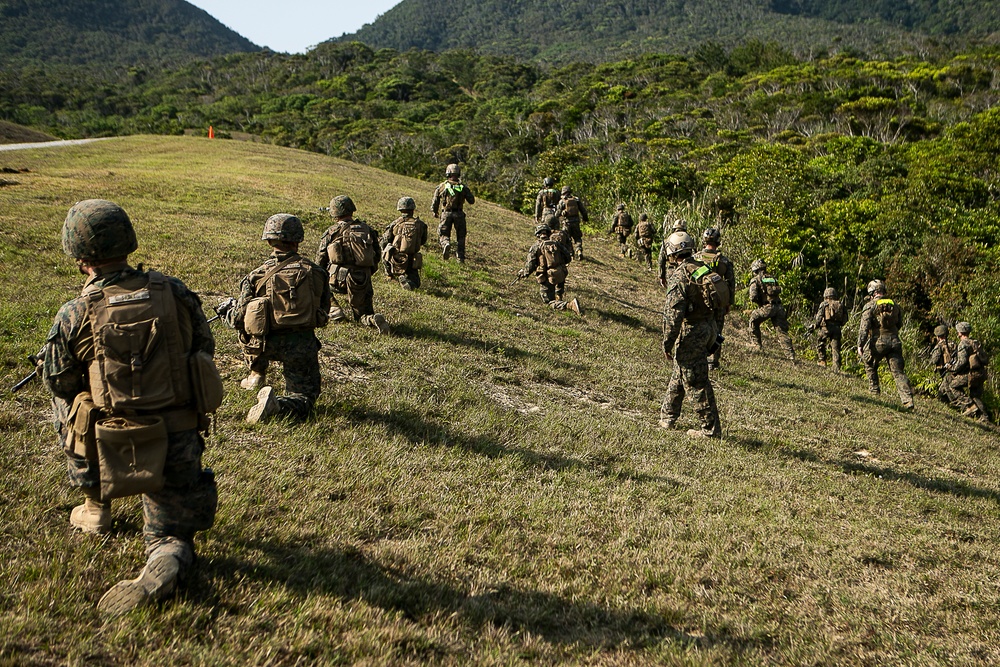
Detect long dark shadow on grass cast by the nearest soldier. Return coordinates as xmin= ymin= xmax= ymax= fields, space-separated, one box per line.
xmin=195 ymin=535 xmax=773 ymax=658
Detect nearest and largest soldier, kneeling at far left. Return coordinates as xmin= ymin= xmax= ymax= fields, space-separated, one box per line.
xmin=40 ymin=199 xmax=223 ymax=616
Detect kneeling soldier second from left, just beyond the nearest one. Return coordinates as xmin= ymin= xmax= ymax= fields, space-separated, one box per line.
xmin=225 ymin=213 xmax=331 ymax=424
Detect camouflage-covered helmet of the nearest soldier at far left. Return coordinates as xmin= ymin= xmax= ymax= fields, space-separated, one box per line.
xmin=62 ymin=199 xmax=139 ymax=262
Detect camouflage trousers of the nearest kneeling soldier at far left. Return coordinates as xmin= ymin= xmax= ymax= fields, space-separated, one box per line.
xmin=66 ymin=430 xmax=219 ymax=568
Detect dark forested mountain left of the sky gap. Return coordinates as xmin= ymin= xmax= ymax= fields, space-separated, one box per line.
xmin=0 ymin=0 xmax=260 ymax=67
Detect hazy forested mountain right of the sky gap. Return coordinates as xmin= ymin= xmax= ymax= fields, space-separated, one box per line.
xmin=338 ymin=0 xmax=1000 ymax=63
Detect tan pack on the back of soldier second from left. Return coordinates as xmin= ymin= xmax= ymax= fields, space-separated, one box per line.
xmin=256 ymin=255 xmax=322 ymax=331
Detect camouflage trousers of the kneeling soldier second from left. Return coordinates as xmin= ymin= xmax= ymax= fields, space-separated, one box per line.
xmin=250 ymin=329 xmax=322 ymax=419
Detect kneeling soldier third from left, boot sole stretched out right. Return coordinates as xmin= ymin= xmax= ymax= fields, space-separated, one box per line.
xmin=316 ymin=195 xmax=390 ymax=334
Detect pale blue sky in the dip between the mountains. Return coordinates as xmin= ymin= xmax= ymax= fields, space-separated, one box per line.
xmin=188 ymin=0 xmax=401 ymax=53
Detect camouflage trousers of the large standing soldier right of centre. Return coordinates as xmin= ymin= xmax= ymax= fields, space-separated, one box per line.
xmin=660 ymin=320 xmax=722 ymax=436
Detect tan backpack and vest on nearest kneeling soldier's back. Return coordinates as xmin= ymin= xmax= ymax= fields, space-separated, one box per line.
xmin=83 ymin=271 xmax=192 ymax=415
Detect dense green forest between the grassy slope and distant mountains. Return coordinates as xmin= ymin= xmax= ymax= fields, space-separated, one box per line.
xmin=0 ymin=42 xmax=1000 ymax=396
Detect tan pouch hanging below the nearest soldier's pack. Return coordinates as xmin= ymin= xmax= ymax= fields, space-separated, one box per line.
xmin=95 ymin=416 xmax=168 ymax=500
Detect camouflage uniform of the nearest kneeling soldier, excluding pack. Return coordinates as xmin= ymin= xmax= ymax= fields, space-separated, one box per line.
xmin=42 ymin=264 xmax=218 ymax=588
